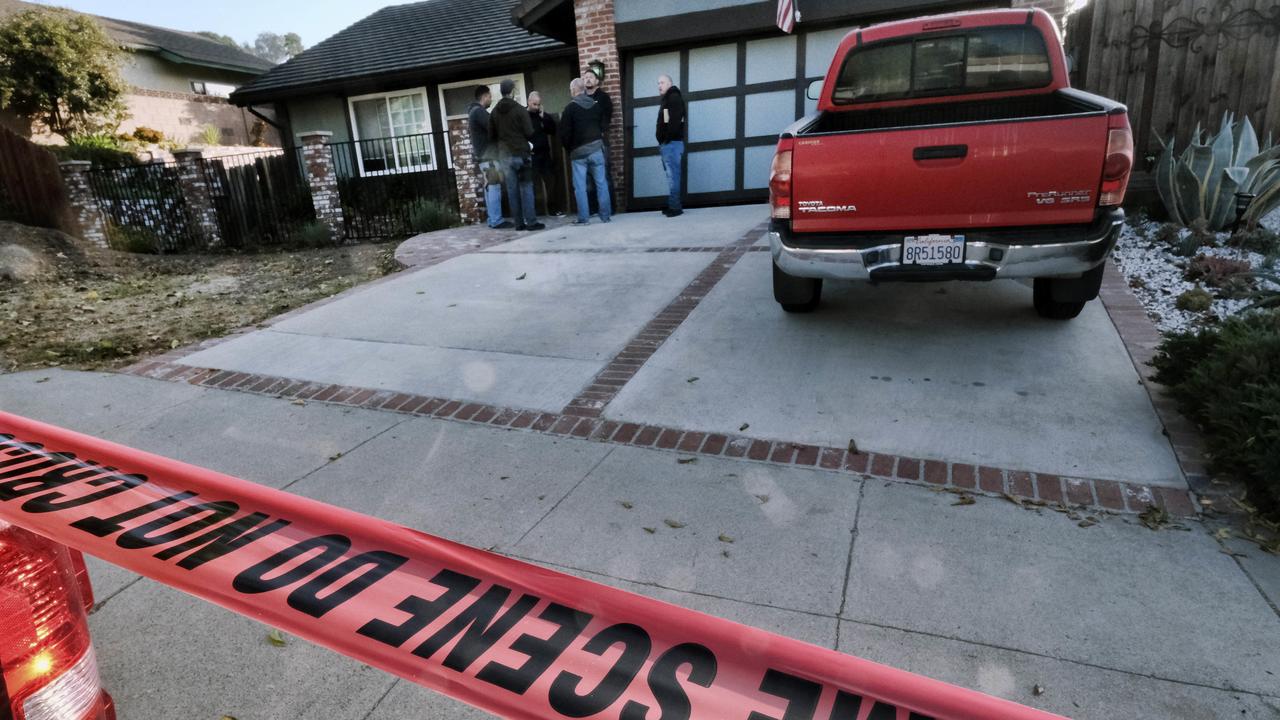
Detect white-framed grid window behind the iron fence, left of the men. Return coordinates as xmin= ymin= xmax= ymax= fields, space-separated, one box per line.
xmin=347 ymin=88 xmax=435 ymax=176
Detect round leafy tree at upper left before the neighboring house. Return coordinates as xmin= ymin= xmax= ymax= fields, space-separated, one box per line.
xmin=0 ymin=9 xmax=125 ymax=137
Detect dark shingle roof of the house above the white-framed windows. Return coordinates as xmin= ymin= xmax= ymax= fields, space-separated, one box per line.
xmin=232 ymin=0 xmax=568 ymax=105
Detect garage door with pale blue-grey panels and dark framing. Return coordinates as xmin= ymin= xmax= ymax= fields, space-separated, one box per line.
xmin=623 ymin=28 xmax=849 ymax=209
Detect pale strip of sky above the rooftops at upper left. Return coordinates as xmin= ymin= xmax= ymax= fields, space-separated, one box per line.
xmin=27 ymin=0 xmax=396 ymax=47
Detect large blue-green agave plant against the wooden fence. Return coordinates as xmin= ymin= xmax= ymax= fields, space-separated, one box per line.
xmin=1156 ymin=113 xmax=1280 ymax=232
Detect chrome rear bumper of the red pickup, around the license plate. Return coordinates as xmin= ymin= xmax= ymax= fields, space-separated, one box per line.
xmin=769 ymin=209 xmax=1124 ymax=282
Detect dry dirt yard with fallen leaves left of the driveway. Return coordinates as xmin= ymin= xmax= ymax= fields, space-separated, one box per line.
xmin=0 ymin=223 xmax=402 ymax=372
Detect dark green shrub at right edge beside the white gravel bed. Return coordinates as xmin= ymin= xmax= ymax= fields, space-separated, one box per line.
xmin=1152 ymin=309 xmax=1280 ymax=514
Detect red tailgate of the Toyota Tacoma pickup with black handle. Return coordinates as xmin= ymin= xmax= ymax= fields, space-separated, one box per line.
xmin=791 ymin=114 xmax=1107 ymax=232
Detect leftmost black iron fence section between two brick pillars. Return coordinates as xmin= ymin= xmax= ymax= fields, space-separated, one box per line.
xmin=87 ymin=163 xmax=204 ymax=252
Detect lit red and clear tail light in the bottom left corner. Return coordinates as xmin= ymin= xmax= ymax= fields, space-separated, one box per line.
xmin=0 ymin=521 xmax=115 ymax=720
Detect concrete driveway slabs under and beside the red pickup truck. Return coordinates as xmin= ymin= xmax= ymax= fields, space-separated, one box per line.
xmin=182 ymin=206 xmax=1185 ymax=488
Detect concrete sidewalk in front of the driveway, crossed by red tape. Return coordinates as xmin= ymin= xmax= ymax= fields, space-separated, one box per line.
xmin=0 ymin=370 xmax=1280 ymax=720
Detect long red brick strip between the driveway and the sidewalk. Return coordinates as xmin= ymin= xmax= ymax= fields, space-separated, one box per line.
xmin=125 ymin=359 xmax=1196 ymax=518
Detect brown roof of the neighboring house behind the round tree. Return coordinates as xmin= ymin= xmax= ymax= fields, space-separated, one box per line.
xmin=0 ymin=0 xmax=275 ymax=74
